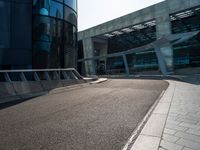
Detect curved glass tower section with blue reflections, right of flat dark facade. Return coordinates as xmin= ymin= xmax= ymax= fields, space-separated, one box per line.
xmin=32 ymin=0 xmax=77 ymax=69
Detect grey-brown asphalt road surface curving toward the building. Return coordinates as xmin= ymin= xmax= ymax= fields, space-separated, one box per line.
xmin=0 ymin=79 xmax=168 ymax=150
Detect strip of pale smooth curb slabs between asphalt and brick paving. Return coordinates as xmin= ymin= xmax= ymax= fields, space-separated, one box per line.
xmin=127 ymin=81 xmax=176 ymax=150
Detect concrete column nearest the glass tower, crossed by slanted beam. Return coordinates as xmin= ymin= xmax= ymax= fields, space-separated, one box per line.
xmin=83 ymin=38 xmax=96 ymax=75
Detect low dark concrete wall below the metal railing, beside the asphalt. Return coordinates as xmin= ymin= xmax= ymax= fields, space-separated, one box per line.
xmin=0 ymin=80 xmax=85 ymax=104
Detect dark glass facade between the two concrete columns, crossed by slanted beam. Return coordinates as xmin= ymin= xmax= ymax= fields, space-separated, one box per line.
xmin=106 ymin=22 xmax=158 ymax=74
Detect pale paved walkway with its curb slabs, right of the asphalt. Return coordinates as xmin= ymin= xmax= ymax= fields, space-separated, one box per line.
xmin=131 ymin=78 xmax=200 ymax=150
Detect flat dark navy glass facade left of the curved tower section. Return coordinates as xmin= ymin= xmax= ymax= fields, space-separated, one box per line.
xmin=0 ymin=0 xmax=32 ymax=69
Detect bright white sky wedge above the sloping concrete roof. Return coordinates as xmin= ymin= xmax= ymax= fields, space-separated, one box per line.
xmin=78 ymin=0 xmax=163 ymax=31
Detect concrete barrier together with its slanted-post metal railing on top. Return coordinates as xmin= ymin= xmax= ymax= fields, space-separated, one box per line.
xmin=0 ymin=68 xmax=85 ymax=103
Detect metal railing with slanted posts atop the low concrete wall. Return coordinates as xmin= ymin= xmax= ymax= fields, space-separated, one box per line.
xmin=0 ymin=68 xmax=83 ymax=82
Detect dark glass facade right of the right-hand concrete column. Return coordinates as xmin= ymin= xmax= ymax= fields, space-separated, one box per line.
xmin=171 ymin=7 xmax=200 ymax=69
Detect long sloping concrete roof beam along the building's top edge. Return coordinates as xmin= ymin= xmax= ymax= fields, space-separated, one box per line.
xmin=78 ymin=0 xmax=200 ymax=40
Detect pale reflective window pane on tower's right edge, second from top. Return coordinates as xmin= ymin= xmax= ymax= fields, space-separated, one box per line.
xmin=64 ymin=6 xmax=77 ymax=25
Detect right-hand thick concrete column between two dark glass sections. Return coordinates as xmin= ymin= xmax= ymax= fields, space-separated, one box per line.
xmin=156 ymin=3 xmax=173 ymax=75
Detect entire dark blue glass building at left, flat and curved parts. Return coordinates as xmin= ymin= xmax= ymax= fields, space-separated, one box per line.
xmin=0 ymin=0 xmax=77 ymax=69
